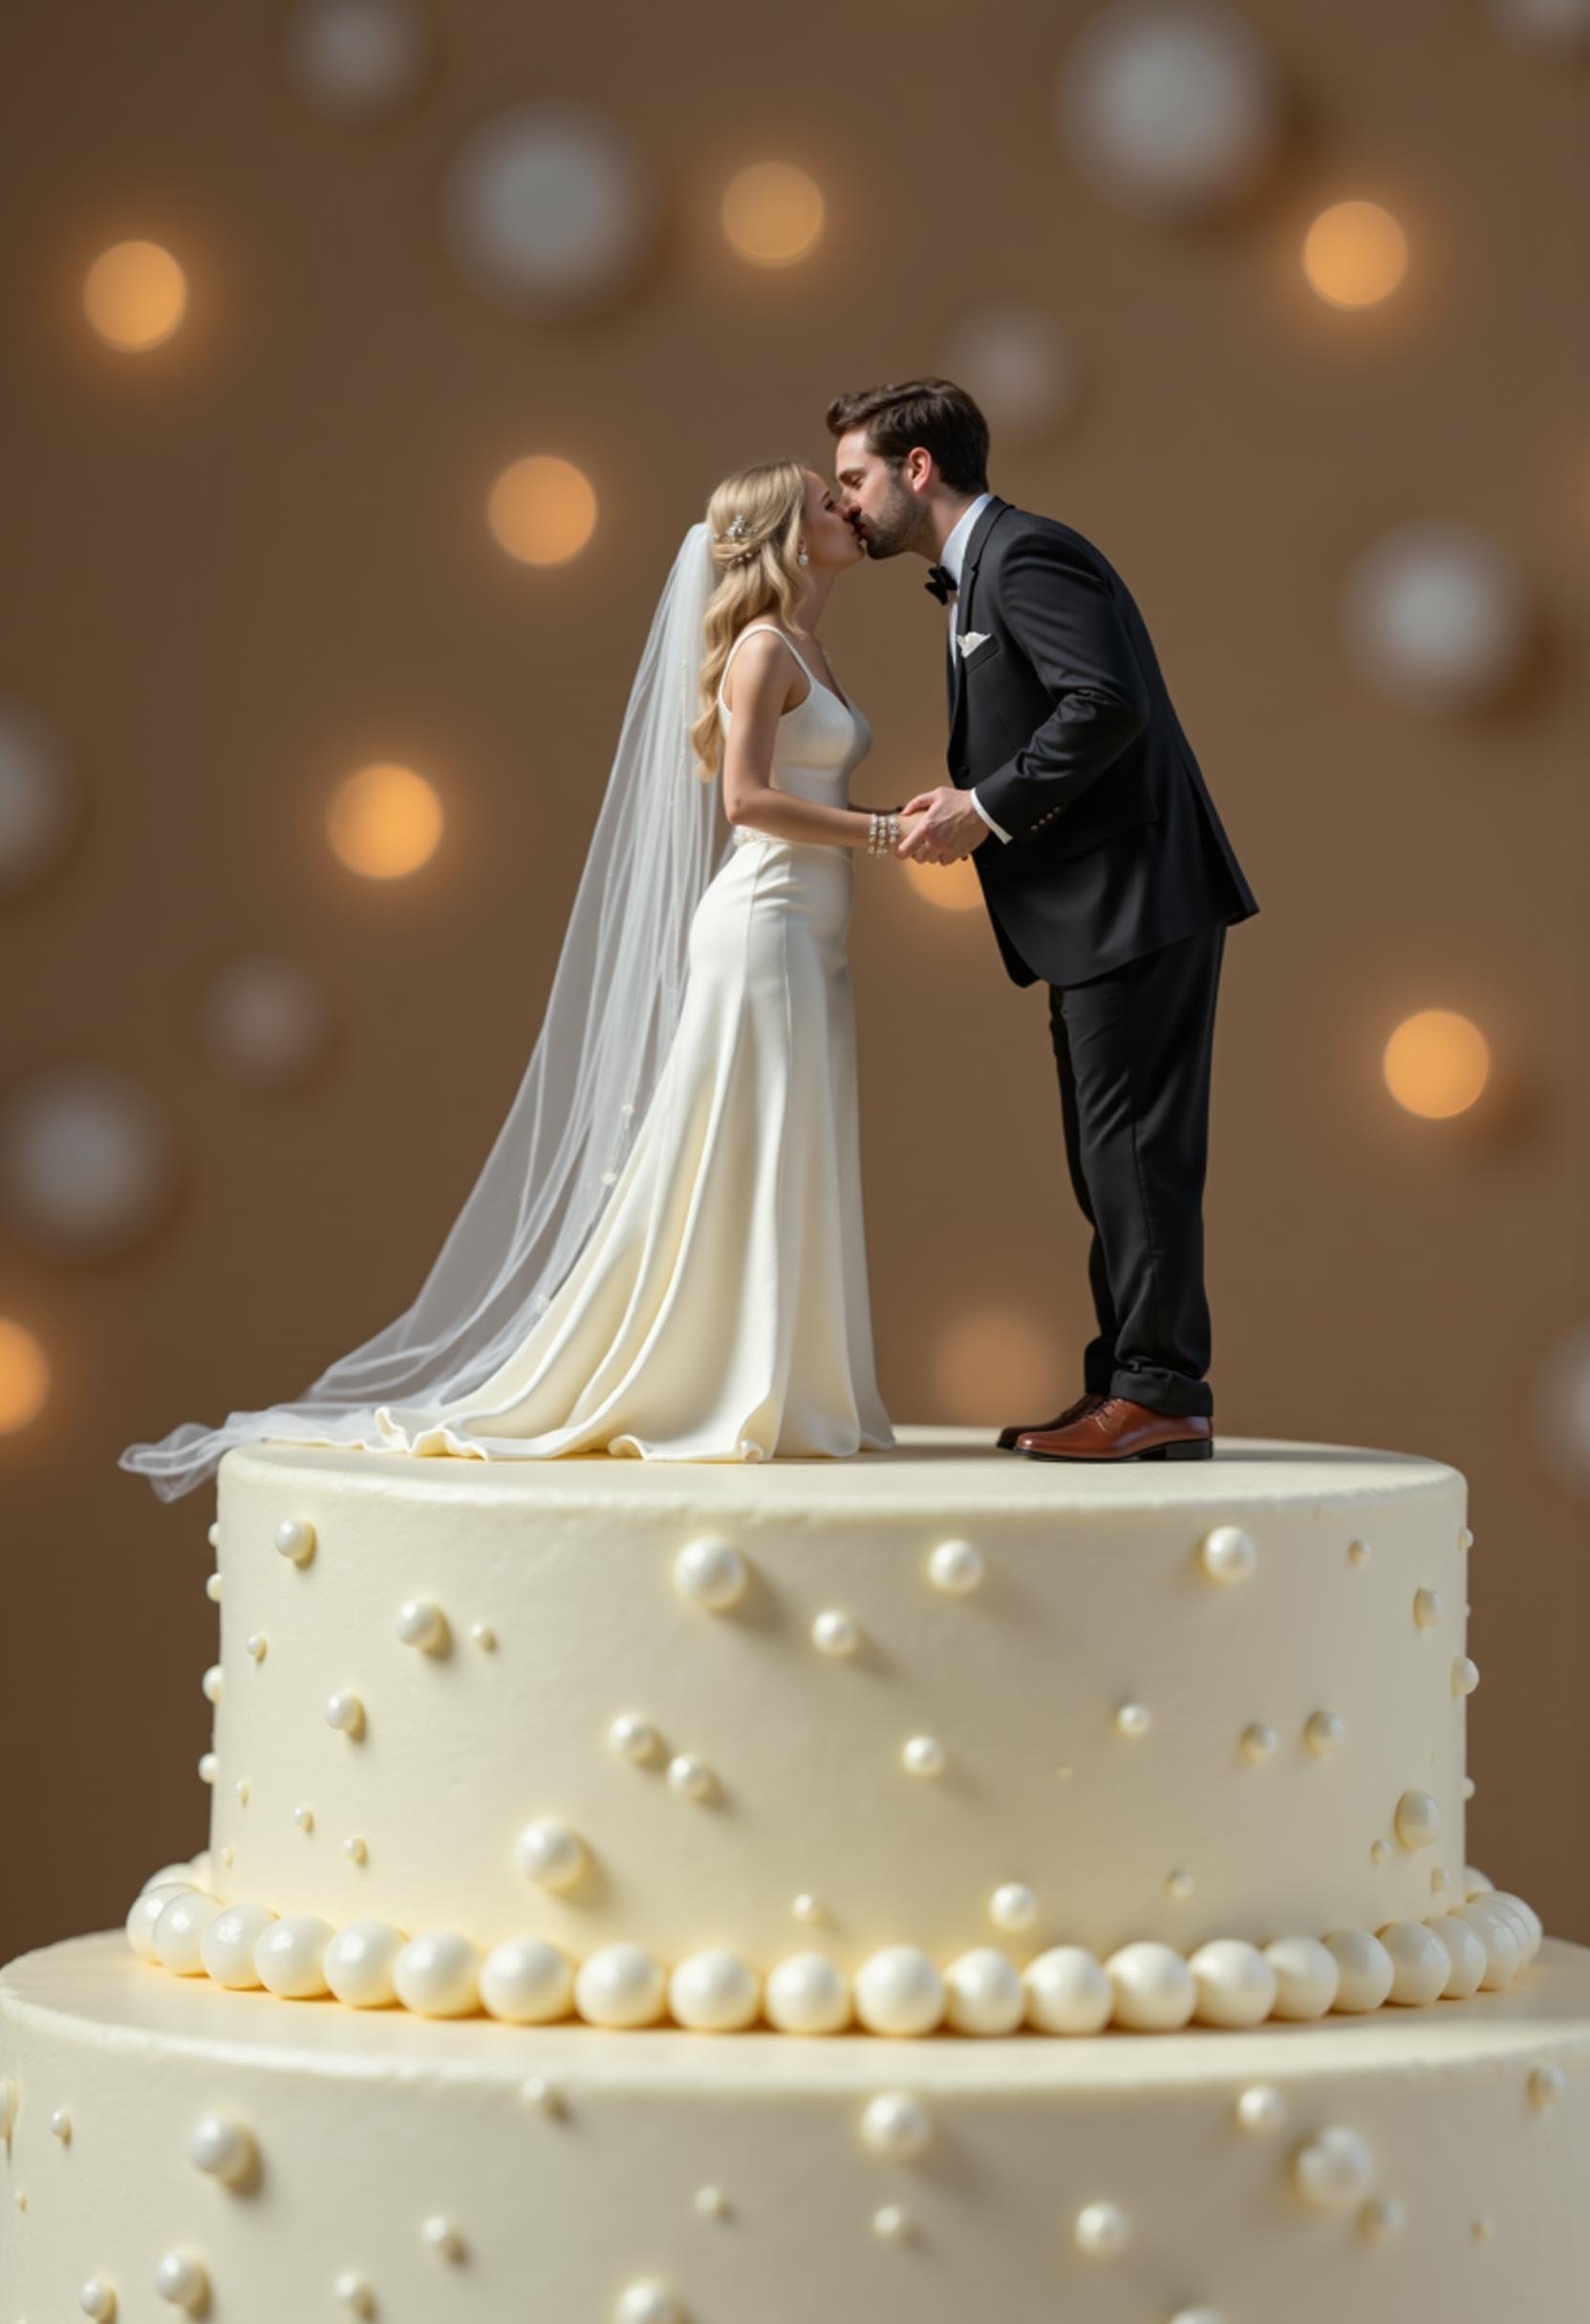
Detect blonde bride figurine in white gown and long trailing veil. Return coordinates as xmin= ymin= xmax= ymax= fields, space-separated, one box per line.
xmin=118 ymin=461 xmax=918 ymax=1501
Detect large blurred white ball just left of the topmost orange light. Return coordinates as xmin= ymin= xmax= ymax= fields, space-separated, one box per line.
xmin=441 ymin=97 xmax=654 ymax=313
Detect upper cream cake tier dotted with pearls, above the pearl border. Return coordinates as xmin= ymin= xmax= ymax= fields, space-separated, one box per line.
xmin=204 ymin=1427 xmax=1476 ymax=1973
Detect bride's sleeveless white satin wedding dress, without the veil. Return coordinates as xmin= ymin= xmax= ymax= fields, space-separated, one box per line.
xmin=364 ymin=623 xmax=895 ymax=1459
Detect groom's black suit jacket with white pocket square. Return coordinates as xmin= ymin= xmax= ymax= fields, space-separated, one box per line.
xmin=949 ymin=495 xmax=1257 ymax=985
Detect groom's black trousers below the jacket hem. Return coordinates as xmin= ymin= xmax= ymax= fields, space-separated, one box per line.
xmin=1048 ymin=920 xmax=1225 ymax=1413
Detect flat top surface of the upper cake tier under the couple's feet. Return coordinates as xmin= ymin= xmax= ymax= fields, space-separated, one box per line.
xmin=221 ymin=1425 xmax=1462 ymax=1520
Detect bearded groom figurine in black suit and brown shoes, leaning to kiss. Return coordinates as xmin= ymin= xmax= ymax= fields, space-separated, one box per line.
xmin=827 ymin=378 xmax=1257 ymax=1459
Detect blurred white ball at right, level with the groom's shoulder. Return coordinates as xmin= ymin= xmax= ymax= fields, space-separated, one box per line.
xmin=1342 ymin=518 xmax=1530 ymax=711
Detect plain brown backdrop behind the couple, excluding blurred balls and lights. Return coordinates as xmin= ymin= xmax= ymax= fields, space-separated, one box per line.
xmin=0 ymin=0 xmax=1590 ymax=1957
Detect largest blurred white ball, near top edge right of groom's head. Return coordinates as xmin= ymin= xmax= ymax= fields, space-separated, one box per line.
xmin=1058 ymin=0 xmax=1285 ymax=216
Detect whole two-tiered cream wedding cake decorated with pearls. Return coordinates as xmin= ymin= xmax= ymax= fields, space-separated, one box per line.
xmin=0 ymin=1427 xmax=1590 ymax=2324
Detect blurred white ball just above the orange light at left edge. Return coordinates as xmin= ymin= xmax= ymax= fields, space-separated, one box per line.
xmin=0 ymin=1065 xmax=174 ymax=1258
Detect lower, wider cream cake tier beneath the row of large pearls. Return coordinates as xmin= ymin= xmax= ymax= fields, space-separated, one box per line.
xmin=0 ymin=1929 xmax=1590 ymax=2324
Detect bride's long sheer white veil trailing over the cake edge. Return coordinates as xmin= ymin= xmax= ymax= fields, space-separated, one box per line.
xmin=118 ymin=523 xmax=730 ymax=1501
